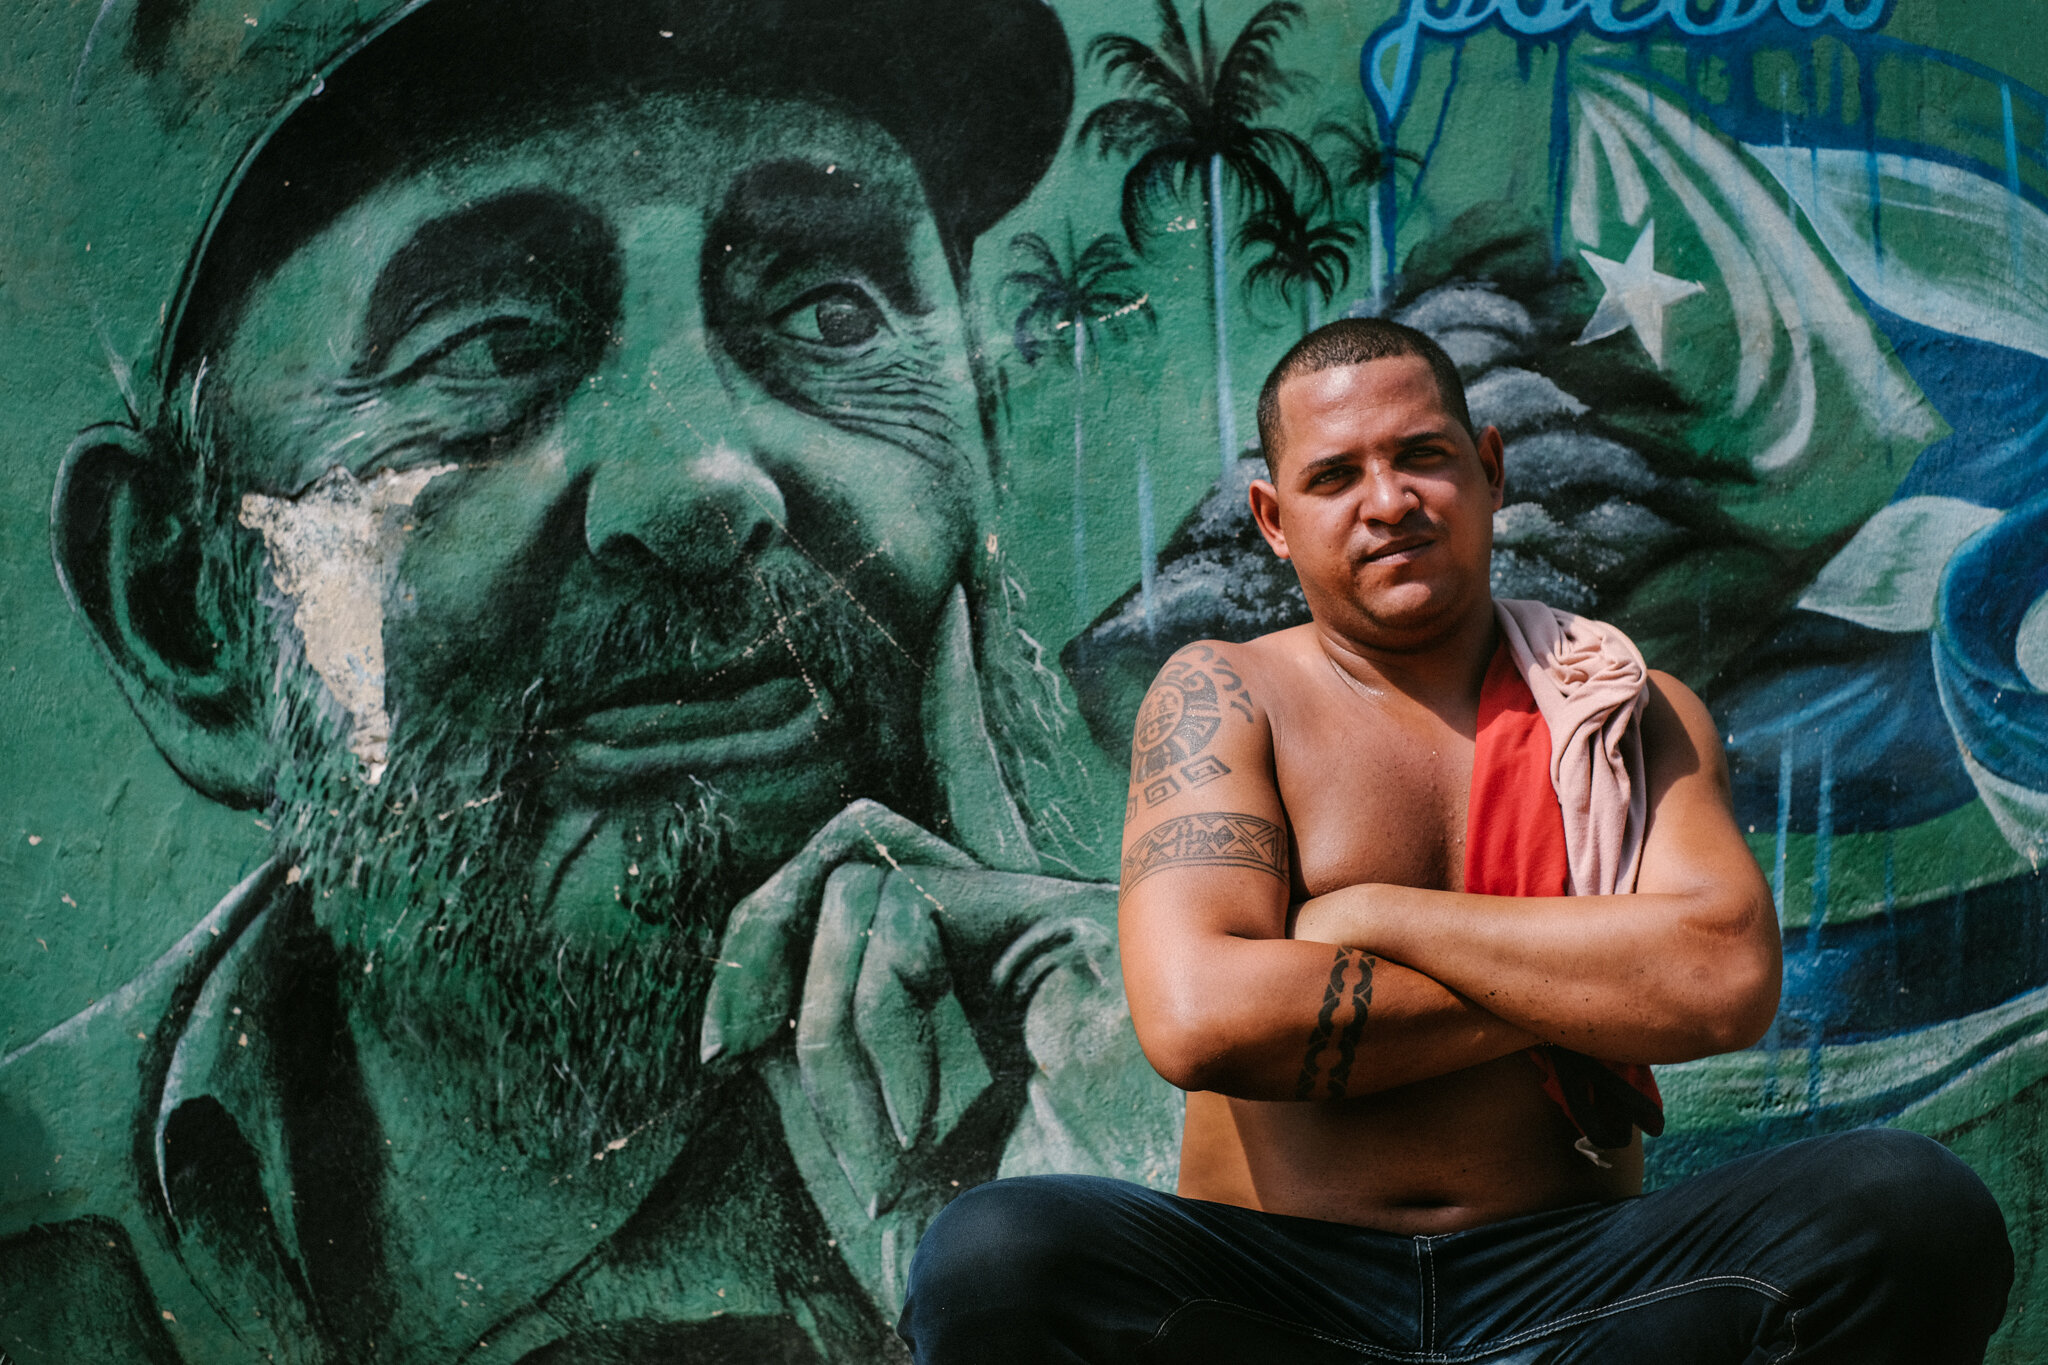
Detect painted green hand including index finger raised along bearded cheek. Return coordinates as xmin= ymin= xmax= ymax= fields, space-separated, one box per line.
xmin=702 ymin=591 xmax=1069 ymax=1314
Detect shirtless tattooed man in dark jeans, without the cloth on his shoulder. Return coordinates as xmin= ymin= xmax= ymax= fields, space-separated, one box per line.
xmin=899 ymin=321 xmax=2011 ymax=1365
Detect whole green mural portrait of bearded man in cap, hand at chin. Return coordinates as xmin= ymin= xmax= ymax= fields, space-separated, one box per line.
xmin=0 ymin=0 xmax=1171 ymax=1361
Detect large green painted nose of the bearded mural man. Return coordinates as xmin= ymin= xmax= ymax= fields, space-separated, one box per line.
xmin=571 ymin=375 xmax=788 ymax=579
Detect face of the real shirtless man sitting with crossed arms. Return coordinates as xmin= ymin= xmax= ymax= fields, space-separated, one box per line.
xmin=1253 ymin=356 xmax=1501 ymax=649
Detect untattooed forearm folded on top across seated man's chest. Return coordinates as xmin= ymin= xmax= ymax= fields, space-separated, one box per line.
xmin=1292 ymin=886 xmax=1778 ymax=1062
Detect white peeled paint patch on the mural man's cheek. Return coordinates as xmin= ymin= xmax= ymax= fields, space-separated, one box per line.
xmin=242 ymin=465 xmax=455 ymax=786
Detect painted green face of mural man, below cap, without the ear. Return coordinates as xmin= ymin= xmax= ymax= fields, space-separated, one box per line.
xmin=201 ymin=94 xmax=987 ymax=912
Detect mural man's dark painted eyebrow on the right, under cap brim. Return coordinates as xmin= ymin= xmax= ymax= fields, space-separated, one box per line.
xmin=705 ymin=160 xmax=932 ymax=313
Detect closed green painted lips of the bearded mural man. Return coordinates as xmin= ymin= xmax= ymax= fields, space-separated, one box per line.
xmin=555 ymin=673 xmax=836 ymax=778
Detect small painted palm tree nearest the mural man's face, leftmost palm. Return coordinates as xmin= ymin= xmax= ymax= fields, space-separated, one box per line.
xmin=1004 ymin=223 xmax=1153 ymax=630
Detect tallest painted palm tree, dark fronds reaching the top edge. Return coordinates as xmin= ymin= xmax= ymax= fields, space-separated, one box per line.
xmin=1075 ymin=0 xmax=1329 ymax=473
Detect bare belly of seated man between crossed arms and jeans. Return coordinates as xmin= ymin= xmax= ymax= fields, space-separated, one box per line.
xmin=1180 ymin=1054 xmax=1642 ymax=1234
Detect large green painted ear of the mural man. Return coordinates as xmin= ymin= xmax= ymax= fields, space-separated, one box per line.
xmin=49 ymin=426 xmax=272 ymax=806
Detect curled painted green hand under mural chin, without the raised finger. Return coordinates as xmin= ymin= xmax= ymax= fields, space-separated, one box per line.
xmin=705 ymin=802 xmax=1122 ymax=1314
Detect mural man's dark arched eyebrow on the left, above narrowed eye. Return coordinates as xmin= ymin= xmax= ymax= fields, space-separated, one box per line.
xmin=356 ymin=190 xmax=625 ymax=372
